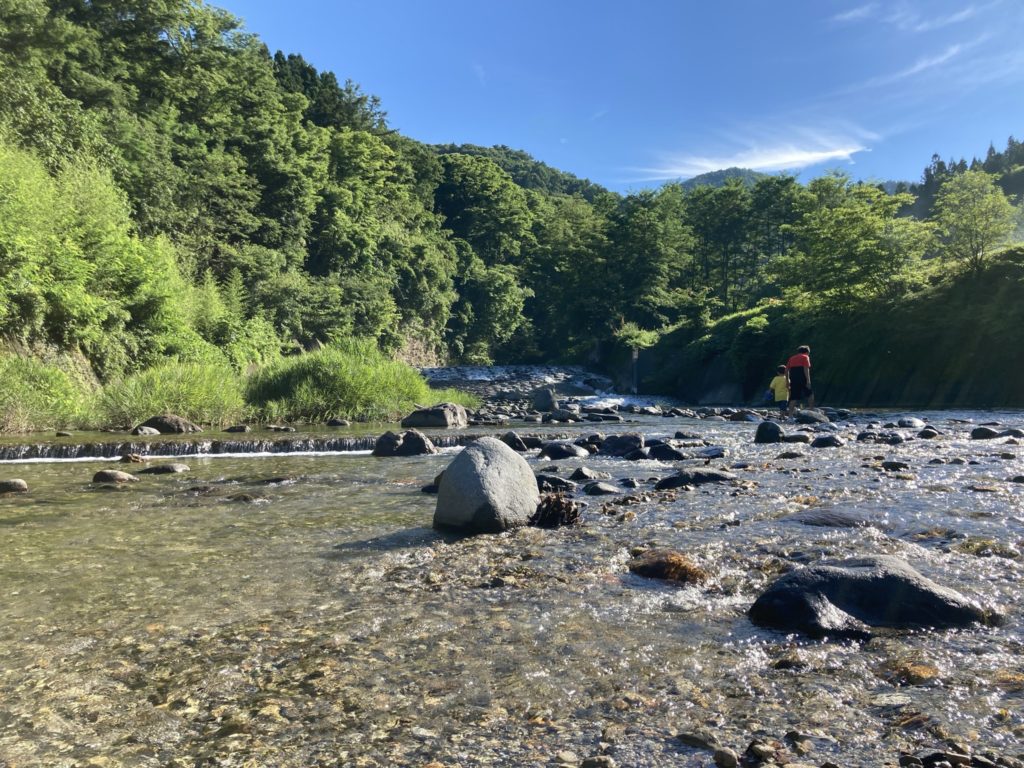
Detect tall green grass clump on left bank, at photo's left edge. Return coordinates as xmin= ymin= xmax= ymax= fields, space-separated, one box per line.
xmin=0 ymin=354 xmax=90 ymax=432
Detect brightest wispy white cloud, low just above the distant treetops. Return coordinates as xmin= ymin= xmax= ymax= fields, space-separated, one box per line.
xmin=636 ymin=129 xmax=873 ymax=181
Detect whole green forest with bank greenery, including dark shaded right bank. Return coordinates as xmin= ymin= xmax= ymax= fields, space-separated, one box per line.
xmin=0 ymin=0 xmax=1024 ymax=430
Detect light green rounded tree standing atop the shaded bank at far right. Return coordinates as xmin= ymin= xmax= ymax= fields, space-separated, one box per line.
xmin=935 ymin=170 xmax=1016 ymax=272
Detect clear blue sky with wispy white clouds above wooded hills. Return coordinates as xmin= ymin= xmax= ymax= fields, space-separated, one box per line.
xmin=220 ymin=0 xmax=1024 ymax=191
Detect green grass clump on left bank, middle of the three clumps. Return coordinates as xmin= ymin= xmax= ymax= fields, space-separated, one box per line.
xmin=97 ymin=361 xmax=246 ymax=427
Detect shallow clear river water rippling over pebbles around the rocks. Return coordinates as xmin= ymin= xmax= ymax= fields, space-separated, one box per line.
xmin=0 ymin=413 xmax=1024 ymax=768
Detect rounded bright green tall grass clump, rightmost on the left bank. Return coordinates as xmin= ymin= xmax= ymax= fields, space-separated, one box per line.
xmin=246 ymin=340 xmax=477 ymax=421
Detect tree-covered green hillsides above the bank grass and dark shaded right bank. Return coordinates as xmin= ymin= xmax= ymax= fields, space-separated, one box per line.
xmin=0 ymin=0 xmax=1024 ymax=415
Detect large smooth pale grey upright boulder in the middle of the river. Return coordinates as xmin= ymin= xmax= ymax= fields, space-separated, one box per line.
xmin=434 ymin=437 xmax=541 ymax=534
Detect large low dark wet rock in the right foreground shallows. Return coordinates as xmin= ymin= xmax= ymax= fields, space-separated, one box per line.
xmin=750 ymin=555 xmax=1000 ymax=638
